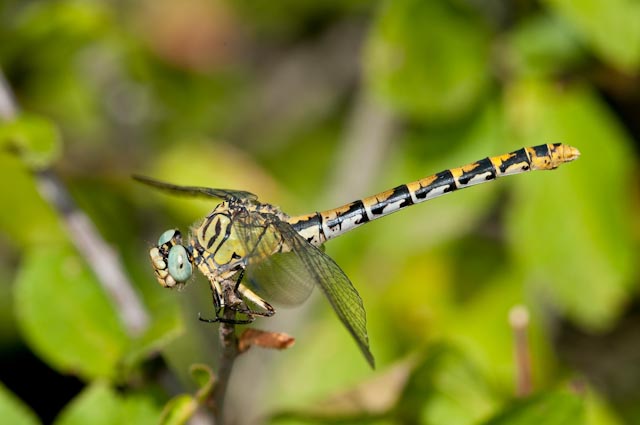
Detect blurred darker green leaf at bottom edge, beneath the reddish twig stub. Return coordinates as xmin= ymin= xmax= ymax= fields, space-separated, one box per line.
xmin=484 ymin=390 xmax=584 ymax=425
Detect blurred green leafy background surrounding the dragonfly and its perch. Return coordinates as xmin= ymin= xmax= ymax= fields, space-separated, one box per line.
xmin=0 ymin=0 xmax=640 ymax=424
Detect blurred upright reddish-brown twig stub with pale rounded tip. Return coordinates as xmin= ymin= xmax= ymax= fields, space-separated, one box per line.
xmin=509 ymin=305 xmax=533 ymax=397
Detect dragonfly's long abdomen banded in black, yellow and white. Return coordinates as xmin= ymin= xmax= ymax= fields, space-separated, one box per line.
xmin=289 ymin=143 xmax=580 ymax=245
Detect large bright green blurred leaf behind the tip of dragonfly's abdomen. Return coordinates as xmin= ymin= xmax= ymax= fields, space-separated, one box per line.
xmin=507 ymin=82 xmax=637 ymax=328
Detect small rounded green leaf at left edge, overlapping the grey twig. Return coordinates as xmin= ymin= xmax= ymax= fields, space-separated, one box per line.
xmin=0 ymin=114 xmax=61 ymax=170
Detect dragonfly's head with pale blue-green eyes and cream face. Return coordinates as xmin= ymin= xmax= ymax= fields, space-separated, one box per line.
xmin=149 ymin=229 xmax=193 ymax=288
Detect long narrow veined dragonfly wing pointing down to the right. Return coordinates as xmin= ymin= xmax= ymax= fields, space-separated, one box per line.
xmin=274 ymin=221 xmax=375 ymax=367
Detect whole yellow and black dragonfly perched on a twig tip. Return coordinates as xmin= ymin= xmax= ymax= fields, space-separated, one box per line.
xmin=133 ymin=143 xmax=580 ymax=367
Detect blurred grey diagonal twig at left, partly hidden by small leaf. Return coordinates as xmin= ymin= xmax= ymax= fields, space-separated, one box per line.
xmin=0 ymin=70 xmax=149 ymax=336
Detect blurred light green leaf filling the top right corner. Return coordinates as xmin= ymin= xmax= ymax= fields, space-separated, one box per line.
xmin=546 ymin=0 xmax=640 ymax=72
